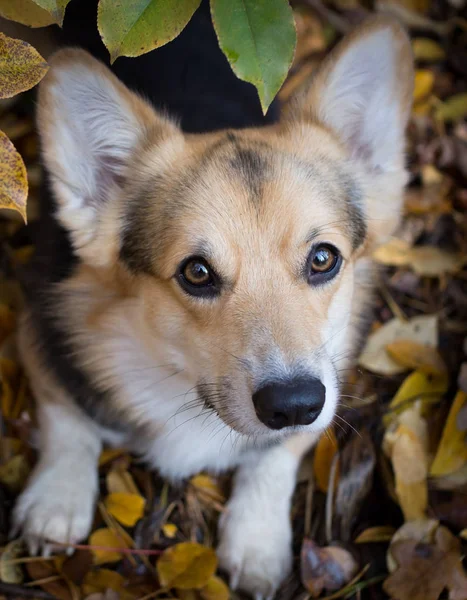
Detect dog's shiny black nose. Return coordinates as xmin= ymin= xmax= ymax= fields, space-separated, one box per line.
xmin=253 ymin=377 xmax=326 ymax=429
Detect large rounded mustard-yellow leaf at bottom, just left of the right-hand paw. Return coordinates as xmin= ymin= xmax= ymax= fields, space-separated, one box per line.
xmin=157 ymin=542 xmax=217 ymax=590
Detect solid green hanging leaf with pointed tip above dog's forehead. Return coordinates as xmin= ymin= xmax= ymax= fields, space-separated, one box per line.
xmin=211 ymin=0 xmax=296 ymax=113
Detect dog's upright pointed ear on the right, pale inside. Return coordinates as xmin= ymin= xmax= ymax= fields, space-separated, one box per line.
xmin=292 ymin=17 xmax=413 ymax=172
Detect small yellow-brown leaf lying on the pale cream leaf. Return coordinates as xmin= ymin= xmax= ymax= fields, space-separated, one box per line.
xmin=386 ymin=340 xmax=446 ymax=377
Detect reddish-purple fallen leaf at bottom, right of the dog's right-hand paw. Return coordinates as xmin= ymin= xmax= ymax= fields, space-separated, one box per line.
xmin=300 ymin=539 xmax=358 ymax=598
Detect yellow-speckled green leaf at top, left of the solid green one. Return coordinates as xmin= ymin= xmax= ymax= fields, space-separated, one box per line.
xmin=97 ymin=0 xmax=201 ymax=62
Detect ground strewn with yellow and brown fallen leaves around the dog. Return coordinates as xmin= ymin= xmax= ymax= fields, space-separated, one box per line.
xmin=0 ymin=0 xmax=467 ymax=600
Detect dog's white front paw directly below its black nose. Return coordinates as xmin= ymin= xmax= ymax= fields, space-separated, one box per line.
xmin=217 ymin=498 xmax=292 ymax=600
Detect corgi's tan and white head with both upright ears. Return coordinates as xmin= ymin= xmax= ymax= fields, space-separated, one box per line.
xmin=39 ymin=18 xmax=412 ymax=436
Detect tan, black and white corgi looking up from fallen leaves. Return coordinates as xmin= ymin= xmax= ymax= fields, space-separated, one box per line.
xmin=10 ymin=2 xmax=413 ymax=599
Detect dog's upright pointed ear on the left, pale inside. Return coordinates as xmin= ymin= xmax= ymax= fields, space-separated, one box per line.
xmin=38 ymin=49 xmax=183 ymax=260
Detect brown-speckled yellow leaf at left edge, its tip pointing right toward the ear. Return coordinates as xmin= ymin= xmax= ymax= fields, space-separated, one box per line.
xmin=0 ymin=33 xmax=49 ymax=98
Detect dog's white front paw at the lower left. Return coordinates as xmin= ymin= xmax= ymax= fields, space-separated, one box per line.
xmin=13 ymin=468 xmax=97 ymax=554
